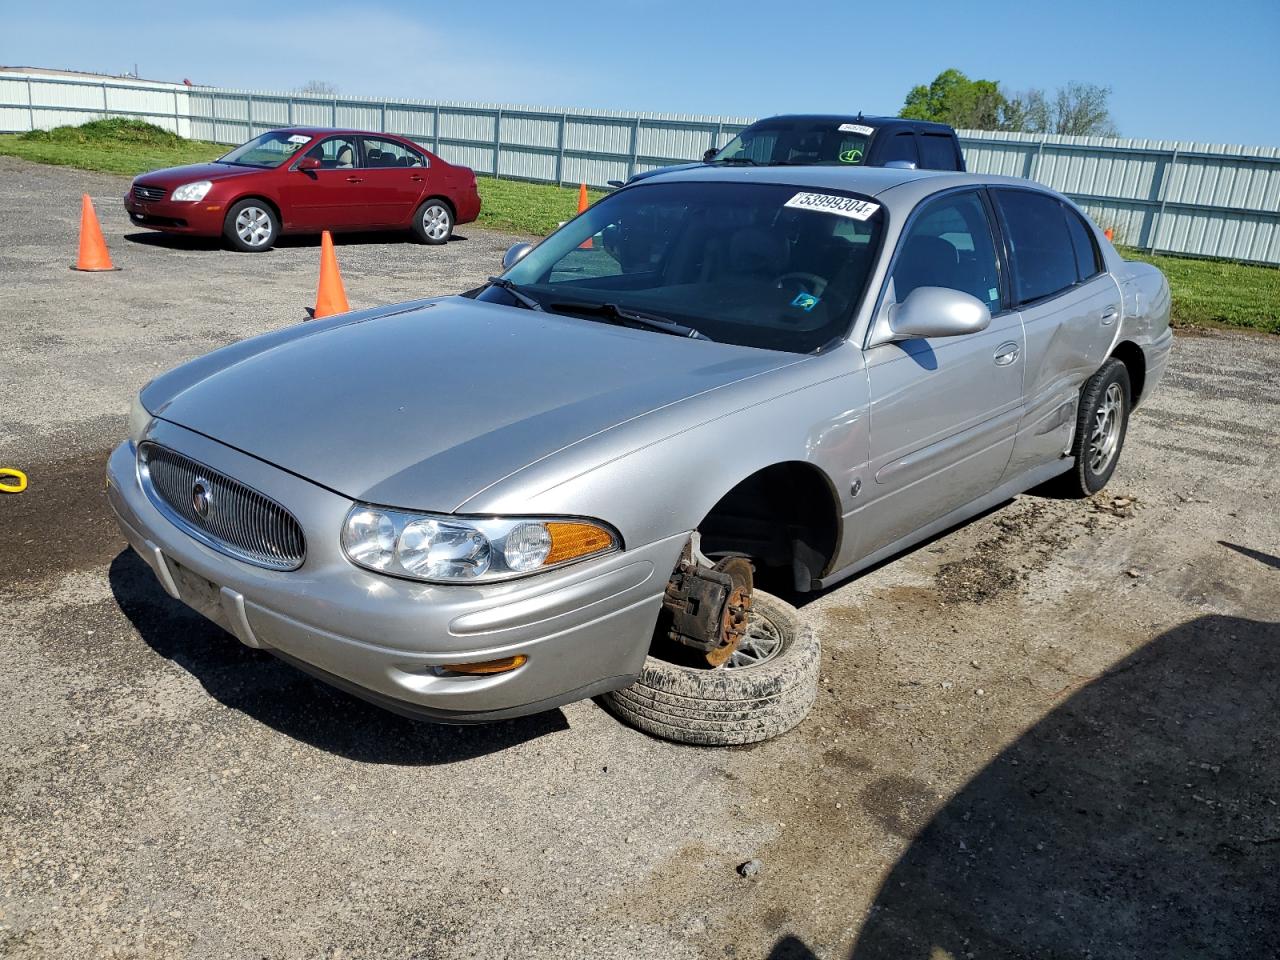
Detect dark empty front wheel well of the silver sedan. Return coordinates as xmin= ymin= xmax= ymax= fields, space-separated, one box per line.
xmin=698 ymin=462 xmax=840 ymax=593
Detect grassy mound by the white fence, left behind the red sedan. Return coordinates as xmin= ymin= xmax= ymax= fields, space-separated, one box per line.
xmin=0 ymin=116 xmax=229 ymax=177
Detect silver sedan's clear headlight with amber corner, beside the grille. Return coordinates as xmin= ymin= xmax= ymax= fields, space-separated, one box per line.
xmin=342 ymin=504 xmax=620 ymax=584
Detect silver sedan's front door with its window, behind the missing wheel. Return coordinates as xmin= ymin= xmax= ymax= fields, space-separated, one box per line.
xmin=858 ymin=189 xmax=1024 ymax=556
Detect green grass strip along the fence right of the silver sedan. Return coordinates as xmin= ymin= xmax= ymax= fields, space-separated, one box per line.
xmin=1120 ymin=247 xmax=1280 ymax=333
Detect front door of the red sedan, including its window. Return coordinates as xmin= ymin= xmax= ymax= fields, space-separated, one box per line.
xmin=280 ymin=134 xmax=369 ymax=230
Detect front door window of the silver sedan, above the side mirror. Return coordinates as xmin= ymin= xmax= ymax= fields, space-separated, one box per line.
xmin=893 ymin=192 xmax=1000 ymax=314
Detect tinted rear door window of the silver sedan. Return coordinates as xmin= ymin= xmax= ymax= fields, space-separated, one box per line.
xmin=992 ymin=189 xmax=1079 ymax=303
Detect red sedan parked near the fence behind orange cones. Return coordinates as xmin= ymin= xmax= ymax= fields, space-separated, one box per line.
xmin=124 ymin=127 xmax=480 ymax=252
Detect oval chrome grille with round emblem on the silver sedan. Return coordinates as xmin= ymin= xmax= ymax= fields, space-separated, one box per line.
xmin=138 ymin=443 xmax=307 ymax=570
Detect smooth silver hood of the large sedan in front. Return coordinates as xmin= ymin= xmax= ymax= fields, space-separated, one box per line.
xmin=143 ymin=297 xmax=803 ymax=512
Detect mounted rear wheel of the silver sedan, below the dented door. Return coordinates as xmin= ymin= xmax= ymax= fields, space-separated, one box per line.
xmin=1056 ymin=357 xmax=1133 ymax=498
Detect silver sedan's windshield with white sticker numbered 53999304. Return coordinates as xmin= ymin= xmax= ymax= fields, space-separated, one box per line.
xmin=479 ymin=182 xmax=884 ymax=353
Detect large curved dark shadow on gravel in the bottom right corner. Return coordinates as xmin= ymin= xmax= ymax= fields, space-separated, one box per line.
xmin=839 ymin=616 xmax=1280 ymax=960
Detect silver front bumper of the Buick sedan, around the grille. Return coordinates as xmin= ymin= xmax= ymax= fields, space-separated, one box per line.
xmin=108 ymin=421 xmax=685 ymax=722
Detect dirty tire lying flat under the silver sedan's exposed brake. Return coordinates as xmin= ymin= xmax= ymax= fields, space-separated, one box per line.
xmin=602 ymin=590 xmax=822 ymax=746
